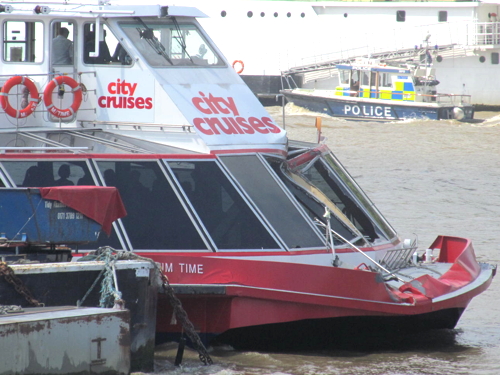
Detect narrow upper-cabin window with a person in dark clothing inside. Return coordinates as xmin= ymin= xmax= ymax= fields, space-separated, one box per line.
xmin=50 ymin=22 xmax=75 ymax=65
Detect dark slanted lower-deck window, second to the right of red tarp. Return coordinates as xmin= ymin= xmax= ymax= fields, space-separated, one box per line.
xmin=168 ymin=161 xmax=279 ymax=250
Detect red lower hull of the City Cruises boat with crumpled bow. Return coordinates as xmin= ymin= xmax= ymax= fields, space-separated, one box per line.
xmin=143 ymin=237 xmax=494 ymax=348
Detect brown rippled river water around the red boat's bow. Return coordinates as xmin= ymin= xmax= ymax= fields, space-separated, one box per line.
xmin=141 ymin=107 xmax=500 ymax=375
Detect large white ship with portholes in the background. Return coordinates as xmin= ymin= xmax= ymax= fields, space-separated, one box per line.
xmin=189 ymin=0 xmax=500 ymax=109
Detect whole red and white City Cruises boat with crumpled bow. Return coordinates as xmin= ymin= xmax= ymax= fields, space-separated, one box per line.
xmin=0 ymin=2 xmax=493 ymax=347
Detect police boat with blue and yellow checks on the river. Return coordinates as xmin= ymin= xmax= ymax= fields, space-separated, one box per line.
xmin=282 ymin=58 xmax=474 ymax=120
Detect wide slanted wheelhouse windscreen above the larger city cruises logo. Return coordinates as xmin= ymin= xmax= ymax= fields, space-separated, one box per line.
xmin=119 ymin=17 xmax=224 ymax=67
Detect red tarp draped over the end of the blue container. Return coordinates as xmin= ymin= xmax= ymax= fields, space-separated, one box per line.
xmin=39 ymin=186 xmax=127 ymax=236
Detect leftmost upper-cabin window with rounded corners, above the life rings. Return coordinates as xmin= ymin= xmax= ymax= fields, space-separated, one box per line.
xmin=3 ymin=21 xmax=44 ymax=63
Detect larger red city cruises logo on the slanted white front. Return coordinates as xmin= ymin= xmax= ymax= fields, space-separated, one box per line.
xmin=191 ymin=91 xmax=281 ymax=135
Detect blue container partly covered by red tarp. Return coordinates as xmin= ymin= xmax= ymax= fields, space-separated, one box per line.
xmin=0 ymin=188 xmax=101 ymax=244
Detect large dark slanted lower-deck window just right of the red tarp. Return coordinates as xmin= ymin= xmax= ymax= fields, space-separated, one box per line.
xmin=97 ymin=161 xmax=207 ymax=250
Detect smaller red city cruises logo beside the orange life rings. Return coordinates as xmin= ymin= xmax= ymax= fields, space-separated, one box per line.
xmin=97 ymin=78 xmax=153 ymax=109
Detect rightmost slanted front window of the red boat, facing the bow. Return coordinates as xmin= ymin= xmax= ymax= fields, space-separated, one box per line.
xmin=318 ymin=153 xmax=396 ymax=239
